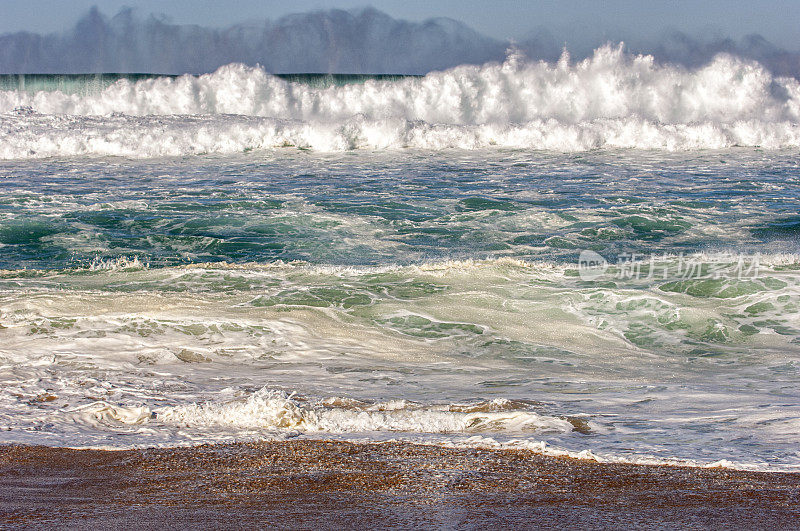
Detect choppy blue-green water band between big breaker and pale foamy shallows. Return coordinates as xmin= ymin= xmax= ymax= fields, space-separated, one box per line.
xmin=0 ymin=150 xmax=800 ymax=269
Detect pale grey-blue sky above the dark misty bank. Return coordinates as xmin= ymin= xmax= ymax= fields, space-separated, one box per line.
xmin=0 ymin=0 xmax=800 ymax=50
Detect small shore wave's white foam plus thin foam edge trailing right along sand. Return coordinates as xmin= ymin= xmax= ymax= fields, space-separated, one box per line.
xmin=57 ymin=388 xmax=800 ymax=471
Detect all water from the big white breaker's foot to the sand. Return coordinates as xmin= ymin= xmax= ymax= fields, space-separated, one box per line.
xmin=0 ymin=149 xmax=800 ymax=470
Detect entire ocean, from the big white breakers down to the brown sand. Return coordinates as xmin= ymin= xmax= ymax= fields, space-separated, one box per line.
xmin=0 ymin=46 xmax=800 ymax=471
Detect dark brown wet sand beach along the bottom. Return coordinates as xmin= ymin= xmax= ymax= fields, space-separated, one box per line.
xmin=0 ymin=440 xmax=800 ymax=529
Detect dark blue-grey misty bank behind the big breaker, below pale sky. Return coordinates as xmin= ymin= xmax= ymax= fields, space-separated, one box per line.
xmin=0 ymin=8 xmax=800 ymax=76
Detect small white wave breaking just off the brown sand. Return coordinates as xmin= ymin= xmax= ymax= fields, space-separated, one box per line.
xmin=76 ymin=388 xmax=590 ymax=434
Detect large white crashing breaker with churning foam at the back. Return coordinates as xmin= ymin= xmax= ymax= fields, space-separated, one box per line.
xmin=0 ymin=46 xmax=800 ymax=159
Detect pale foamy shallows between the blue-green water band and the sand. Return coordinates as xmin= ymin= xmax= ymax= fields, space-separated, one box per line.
xmin=0 ymin=260 xmax=800 ymax=470
